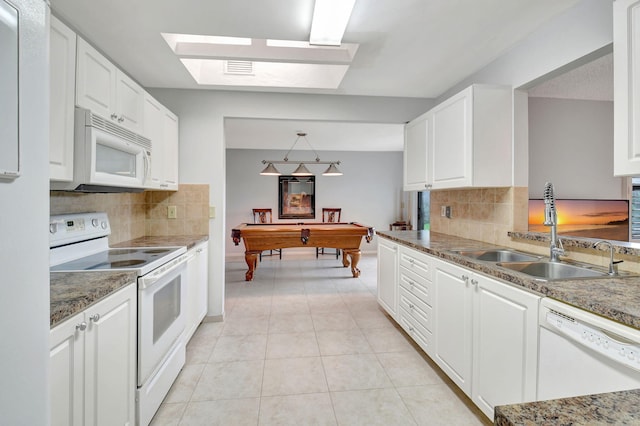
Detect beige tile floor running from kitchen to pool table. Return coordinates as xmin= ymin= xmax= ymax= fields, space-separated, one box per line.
xmin=152 ymin=255 xmax=491 ymax=426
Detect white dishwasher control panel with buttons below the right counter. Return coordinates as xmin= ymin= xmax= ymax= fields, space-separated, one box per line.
xmin=544 ymin=309 xmax=640 ymax=371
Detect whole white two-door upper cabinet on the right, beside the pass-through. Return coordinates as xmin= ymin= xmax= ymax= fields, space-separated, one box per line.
xmin=404 ymin=85 xmax=513 ymax=191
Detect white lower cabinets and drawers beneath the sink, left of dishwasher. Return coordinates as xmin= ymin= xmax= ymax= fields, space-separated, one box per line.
xmin=378 ymin=238 xmax=541 ymax=419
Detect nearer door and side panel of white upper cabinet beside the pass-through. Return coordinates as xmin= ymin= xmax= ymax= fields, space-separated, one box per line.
xmin=430 ymin=85 xmax=513 ymax=189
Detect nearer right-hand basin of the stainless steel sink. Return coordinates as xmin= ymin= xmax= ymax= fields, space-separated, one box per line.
xmin=497 ymin=261 xmax=610 ymax=281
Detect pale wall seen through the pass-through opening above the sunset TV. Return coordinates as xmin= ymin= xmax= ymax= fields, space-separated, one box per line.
xmin=529 ymin=98 xmax=626 ymax=199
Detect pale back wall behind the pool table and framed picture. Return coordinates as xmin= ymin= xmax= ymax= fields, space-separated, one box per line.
xmin=225 ymin=149 xmax=402 ymax=260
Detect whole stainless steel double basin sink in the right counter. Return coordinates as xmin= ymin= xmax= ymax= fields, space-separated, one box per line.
xmin=451 ymin=249 xmax=629 ymax=281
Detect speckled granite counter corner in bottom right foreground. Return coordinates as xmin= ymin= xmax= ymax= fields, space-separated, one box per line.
xmin=494 ymin=390 xmax=640 ymax=426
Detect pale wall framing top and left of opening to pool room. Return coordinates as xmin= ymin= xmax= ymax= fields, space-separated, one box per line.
xmin=149 ymin=89 xmax=434 ymax=316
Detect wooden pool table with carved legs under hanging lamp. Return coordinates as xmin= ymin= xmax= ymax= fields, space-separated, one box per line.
xmin=231 ymin=222 xmax=375 ymax=281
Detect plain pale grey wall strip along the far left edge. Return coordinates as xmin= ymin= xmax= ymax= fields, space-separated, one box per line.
xmin=0 ymin=0 xmax=49 ymax=425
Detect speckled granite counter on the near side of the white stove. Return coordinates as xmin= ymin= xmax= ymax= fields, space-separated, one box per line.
xmin=49 ymin=271 xmax=137 ymax=328
